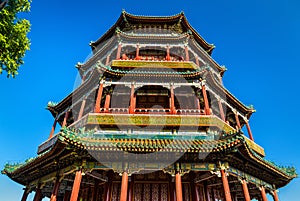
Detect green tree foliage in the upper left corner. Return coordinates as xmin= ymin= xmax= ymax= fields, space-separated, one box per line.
xmin=0 ymin=0 xmax=31 ymax=77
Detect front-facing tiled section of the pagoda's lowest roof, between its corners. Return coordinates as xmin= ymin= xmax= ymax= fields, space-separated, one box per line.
xmin=61 ymin=134 xmax=241 ymax=153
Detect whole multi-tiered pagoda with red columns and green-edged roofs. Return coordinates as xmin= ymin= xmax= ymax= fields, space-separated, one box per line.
xmin=2 ymin=11 xmax=296 ymax=201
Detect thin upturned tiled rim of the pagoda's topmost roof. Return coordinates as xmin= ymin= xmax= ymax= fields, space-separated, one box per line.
xmin=91 ymin=11 xmax=215 ymax=54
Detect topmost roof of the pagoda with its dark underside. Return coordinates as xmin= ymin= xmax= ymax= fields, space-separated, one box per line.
xmin=90 ymin=10 xmax=215 ymax=54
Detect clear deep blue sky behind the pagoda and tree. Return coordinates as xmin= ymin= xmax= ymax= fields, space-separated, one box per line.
xmin=0 ymin=0 xmax=300 ymax=201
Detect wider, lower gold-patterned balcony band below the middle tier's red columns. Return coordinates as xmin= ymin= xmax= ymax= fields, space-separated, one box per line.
xmin=69 ymin=111 xmax=236 ymax=133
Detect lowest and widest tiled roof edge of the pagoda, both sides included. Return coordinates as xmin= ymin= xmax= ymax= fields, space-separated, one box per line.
xmin=2 ymin=130 xmax=296 ymax=188
